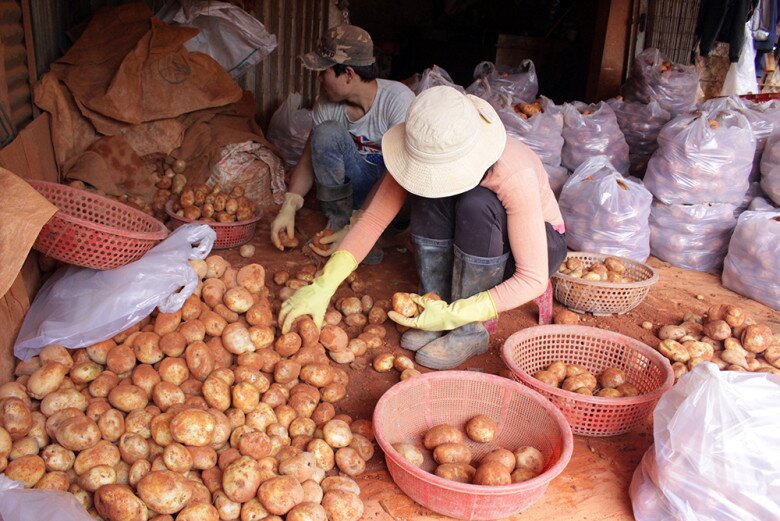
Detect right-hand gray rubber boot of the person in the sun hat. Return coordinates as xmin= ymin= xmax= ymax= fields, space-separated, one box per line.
xmin=415 ymin=246 xmax=509 ymax=369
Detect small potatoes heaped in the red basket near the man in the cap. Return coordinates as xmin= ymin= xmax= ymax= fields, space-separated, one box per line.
xmin=166 ymin=182 xmax=256 ymax=223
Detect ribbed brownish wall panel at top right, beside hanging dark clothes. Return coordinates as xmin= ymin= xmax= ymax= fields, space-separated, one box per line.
xmin=645 ymin=0 xmax=701 ymax=63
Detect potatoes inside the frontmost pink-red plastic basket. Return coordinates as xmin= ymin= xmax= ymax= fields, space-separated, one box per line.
xmin=393 ymin=415 xmax=544 ymax=486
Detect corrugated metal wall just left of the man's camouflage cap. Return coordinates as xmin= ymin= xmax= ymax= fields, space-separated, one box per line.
xmin=247 ymin=0 xmax=333 ymax=129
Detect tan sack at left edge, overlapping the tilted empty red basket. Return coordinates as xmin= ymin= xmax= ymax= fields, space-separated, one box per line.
xmin=0 ymin=168 xmax=57 ymax=296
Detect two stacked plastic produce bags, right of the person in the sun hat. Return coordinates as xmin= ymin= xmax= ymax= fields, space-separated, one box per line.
xmin=644 ymin=110 xmax=756 ymax=271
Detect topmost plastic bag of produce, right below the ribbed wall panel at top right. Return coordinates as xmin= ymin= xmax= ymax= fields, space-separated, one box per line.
xmin=621 ymin=48 xmax=699 ymax=116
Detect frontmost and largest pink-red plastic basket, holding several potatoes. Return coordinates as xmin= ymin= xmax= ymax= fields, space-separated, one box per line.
xmin=373 ymin=371 xmax=573 ymax=519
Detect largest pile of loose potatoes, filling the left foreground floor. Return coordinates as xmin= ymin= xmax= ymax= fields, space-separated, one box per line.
xmin=0 ymin=255 xmax=374 ymax=521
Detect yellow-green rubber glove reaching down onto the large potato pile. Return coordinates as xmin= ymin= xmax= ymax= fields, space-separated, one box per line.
xmin=278 ymin=250 xmax=357 ymax=333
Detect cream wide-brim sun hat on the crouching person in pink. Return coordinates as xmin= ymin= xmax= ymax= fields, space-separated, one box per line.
xmin=382 ymin=86 xmax=506 ymax=198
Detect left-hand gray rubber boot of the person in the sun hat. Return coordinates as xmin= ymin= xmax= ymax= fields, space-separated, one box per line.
xmin=401 ymin=235 xmax=453 ymax=351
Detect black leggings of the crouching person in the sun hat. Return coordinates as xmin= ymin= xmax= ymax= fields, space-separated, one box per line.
xmin=410 ymin=186 xmax=566 ymax=275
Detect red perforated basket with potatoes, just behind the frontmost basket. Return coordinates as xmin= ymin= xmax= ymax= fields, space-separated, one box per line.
xmin=501 ymin=325 xmax=674 ymax=436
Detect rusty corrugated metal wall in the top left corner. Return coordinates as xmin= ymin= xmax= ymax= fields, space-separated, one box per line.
xmin=0 ymin=0 xmax=33 ymax=145
